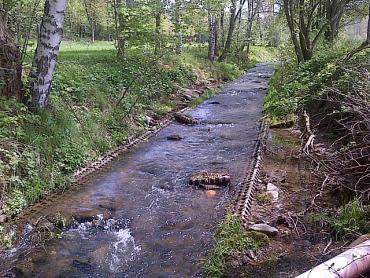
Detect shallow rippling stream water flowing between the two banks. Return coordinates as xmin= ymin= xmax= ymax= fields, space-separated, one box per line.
xmin=3 ymin=65 xmax=272 ymax=277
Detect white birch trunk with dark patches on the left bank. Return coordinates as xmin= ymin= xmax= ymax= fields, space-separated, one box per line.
xmin=30 ymin=0 xmax=67 ymax=108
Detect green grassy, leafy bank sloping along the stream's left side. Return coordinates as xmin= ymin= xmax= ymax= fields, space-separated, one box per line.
xmin=0 ymin=42 xmax=272 ymax=216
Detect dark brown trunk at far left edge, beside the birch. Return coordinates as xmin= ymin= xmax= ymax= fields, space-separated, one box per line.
xmin=0 ymin=11 xmax=23 ymax=100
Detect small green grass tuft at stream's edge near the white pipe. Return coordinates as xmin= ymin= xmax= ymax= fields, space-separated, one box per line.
xmin=205 ymin=214 xmax=269 ymax=278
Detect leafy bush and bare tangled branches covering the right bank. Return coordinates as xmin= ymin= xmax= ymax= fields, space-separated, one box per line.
xmin=265 ymin=45 xmax=370 ymax=238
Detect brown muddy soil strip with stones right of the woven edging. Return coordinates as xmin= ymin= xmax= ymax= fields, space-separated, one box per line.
xmin=227 ymin=129 xmax=343 ymax=278
